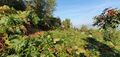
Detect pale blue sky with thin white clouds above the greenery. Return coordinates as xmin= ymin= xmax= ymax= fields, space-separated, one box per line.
xmin=54 ymin=0 xmax=120 ymax=26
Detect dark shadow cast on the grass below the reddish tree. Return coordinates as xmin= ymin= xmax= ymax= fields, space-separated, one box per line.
xmin=84 ymin=37 xmax=120 ymax=57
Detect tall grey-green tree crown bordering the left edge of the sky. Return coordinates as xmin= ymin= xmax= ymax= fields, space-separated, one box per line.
xmin=34 ymin=0 xmax=56 ymax=18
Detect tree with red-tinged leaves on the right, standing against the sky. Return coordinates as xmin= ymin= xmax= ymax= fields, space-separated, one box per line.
xmin=93 ymin=8 xmax=120 ymax=41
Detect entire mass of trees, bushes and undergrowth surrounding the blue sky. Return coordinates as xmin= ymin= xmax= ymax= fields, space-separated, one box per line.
xmin=0 ymin=0 xmax=120 ymax=57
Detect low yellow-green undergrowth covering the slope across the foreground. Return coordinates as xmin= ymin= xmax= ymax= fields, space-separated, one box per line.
xmin=0 ymin=29 xmax=120 ymax=57
